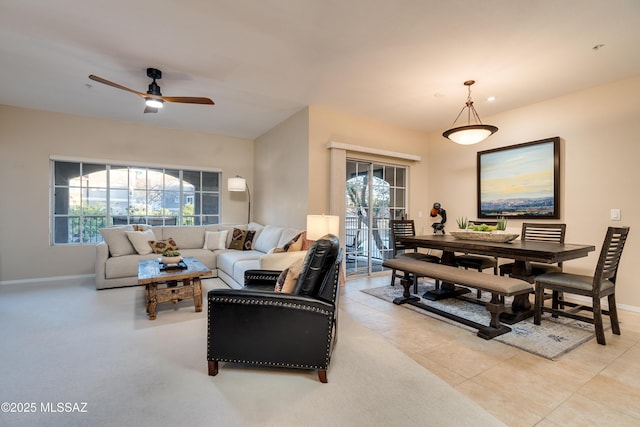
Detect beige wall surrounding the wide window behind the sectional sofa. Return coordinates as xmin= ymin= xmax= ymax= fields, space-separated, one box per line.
xmin=0 ymin=106 xmax=253 ymax=282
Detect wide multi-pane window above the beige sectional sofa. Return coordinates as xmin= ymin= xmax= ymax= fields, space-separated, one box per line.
xmin=51 ymin=160 xmax=220 ymax=244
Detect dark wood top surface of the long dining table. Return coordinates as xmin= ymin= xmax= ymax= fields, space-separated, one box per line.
xmin=398 ymin=234 xmax=596 ymax=264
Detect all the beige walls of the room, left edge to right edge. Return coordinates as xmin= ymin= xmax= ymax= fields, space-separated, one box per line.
xmin=0 ymin=77 xmax=640 ymax=307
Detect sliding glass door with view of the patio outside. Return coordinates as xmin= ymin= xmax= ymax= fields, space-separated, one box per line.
xmin=345 ymin=159 xmax=407 ymax=275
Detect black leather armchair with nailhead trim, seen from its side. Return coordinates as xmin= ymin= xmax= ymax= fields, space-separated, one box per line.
xmin=207 ymin=234 xmax=342 ymax=383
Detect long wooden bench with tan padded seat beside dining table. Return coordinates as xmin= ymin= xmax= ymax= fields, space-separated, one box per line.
xmin=382 ymin=257 xmax=533 ymax=339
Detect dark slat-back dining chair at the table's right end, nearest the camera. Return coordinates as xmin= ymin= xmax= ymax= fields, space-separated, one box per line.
xmin=533 ymin=227 xmax=629 ymax=345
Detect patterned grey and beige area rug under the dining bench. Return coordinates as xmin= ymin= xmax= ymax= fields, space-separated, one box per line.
xmin=362 ymin=280 xmax=610 ymax=360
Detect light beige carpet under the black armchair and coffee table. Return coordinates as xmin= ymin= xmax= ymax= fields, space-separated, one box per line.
xmin=0 ymin=279 xmax=502 ymax=426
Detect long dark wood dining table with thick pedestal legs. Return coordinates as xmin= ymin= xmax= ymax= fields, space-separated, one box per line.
xmin=398 ymin=234 xmax=596 ymax=323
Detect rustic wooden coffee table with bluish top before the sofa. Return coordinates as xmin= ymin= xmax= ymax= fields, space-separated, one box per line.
xmin=138 ymin=257 xmax=211 ymax=320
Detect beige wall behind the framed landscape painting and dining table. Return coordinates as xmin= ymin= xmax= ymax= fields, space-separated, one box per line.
xmin=428 ymin=77 xmax=640 ymax=308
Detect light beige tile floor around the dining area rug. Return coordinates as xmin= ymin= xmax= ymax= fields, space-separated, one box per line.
xmin=340 ymin=274 xmax=640 ymax=427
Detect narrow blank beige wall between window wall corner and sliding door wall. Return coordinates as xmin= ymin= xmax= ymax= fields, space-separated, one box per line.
xmin=253 ymin=108 xmax=312 ymax=229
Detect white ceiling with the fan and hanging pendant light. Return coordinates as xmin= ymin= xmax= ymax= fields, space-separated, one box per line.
xmin=0 ymin=0 xmax=640 ymax=139
